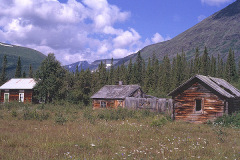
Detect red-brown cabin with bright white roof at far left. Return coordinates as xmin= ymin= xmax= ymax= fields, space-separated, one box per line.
xmin=0 ymin=78 xmax=36 ymax=103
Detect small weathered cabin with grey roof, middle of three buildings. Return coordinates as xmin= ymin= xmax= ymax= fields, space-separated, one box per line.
xmin=91 ymin=84 xmax=144 ymax=108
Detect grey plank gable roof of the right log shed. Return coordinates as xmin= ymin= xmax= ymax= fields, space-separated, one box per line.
xmin=168 ymin=75 xmax=240 ymax=98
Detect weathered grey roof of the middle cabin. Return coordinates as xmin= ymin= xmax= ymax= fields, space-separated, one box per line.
xmin=91 ymin=85 xmax=141 ymax=99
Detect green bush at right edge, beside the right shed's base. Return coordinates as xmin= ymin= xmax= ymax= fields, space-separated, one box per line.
xmin=213 ymin=112 xmax=240 ymax=128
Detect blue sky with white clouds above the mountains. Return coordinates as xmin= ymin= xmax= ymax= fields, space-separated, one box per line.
xmin=0 ymin=0 xmax=235 ymax=65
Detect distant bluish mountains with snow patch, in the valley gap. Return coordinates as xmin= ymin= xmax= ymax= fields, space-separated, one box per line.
xmin=64 ymin=59 xmax=121 ymax=72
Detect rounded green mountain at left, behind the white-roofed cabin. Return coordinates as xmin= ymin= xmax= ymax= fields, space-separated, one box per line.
xmin=0 ymin=42 xmax=46 ymax=78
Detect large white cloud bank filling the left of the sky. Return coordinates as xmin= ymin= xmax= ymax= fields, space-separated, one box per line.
xmin=0 ymin=0 xmax=166 ymax=65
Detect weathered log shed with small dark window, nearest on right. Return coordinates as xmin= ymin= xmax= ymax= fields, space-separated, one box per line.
xmin=168 ymin=75 xmax=240 ymax=123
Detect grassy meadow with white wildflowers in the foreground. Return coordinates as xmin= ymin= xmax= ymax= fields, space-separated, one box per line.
xmin=0 ymin=103 xmax=240 ymax=160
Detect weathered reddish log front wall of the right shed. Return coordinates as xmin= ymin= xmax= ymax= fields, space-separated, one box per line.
xmin=174 ymin=82 xmax=227 ymax=122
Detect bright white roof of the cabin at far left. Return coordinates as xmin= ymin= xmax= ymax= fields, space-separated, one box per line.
xmin=0 ymin=78 xmax=36 ymax=89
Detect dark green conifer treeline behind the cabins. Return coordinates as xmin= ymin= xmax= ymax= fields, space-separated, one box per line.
xmin=1 ymin=47 xmax=240 ymax=105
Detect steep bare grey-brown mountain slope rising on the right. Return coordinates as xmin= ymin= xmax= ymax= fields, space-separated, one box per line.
xmin=118 ymin=0 xmax=240 ymax=65
